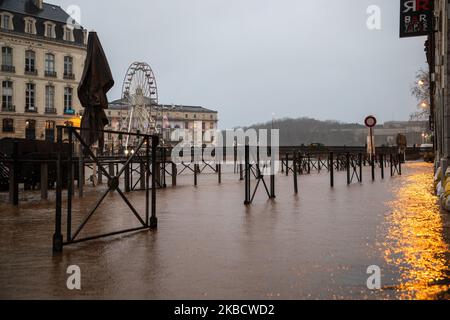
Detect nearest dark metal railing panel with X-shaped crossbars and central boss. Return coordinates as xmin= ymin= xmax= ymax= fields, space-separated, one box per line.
xmin=53 ymin=126 xmax=159 ymax=252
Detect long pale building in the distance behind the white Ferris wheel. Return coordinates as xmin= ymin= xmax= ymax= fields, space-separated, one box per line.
xmin=106 ymin=99 xmax=219 ymax=144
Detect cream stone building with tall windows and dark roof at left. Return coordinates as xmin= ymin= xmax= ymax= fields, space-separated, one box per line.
xmin=0 ymin=0 xmax=87 ymax=141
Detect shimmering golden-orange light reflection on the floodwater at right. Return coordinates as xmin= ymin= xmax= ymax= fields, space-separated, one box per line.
xmin=383 ymin=163 xmax=450 ymax=300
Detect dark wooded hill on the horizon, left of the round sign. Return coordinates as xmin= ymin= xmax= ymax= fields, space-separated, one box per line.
xmin=239 ymin=118 xmax=367 ymax=146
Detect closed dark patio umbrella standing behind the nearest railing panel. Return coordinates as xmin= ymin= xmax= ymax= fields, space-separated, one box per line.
xmin=78 ymin=32 xmax=114 ymax=152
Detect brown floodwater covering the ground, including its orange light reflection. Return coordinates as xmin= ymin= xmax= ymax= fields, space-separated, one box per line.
xmin=0 ymin=163 xmax=450 ymax=299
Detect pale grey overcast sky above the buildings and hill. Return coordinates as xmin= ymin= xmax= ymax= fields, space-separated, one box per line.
xmin=53 ymin=0 xmax=426 ymax=129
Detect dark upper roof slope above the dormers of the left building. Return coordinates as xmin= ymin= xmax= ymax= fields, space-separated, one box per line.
xmin=0 ymin=0 xmax=77 ymax=23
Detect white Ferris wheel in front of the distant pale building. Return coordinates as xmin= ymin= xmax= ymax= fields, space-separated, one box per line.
xmin=120 ymin=62 xmax=158 ymax=148
